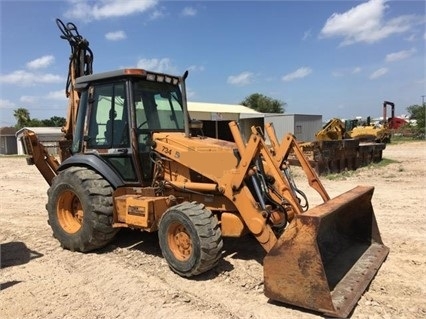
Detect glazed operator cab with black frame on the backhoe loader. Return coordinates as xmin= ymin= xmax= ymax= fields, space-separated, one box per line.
xmin=71 ymin=69 xmax=185 ymax=185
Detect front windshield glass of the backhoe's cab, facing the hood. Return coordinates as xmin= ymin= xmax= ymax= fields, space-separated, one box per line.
xmin=133 ymin=80 xmax=184 ymax=130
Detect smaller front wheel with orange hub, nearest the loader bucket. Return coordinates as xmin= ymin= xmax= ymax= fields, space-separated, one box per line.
xmin=158 ymin=202 xmax=223 ymax=277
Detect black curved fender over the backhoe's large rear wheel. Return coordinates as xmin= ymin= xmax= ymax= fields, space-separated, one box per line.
xmin=58 ymin=154 xmax=124 ymax=189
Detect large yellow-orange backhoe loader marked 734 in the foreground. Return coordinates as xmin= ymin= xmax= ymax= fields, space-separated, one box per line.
xmin=22 ymin=20 xmax=389 ymax=317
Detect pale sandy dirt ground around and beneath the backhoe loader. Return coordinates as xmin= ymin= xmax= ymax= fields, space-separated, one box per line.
xmin=0 ymin=142 xmax=426 ymax=319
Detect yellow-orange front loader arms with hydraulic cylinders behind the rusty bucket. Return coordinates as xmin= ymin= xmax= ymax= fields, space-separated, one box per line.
xmin=213 ymin=122 xmax=330 ymax=252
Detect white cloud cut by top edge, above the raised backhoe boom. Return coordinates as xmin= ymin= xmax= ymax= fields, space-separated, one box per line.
xmin=65 ymin=0 xmax=158 ymax=20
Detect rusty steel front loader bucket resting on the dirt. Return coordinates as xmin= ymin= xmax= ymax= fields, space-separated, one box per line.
xmin=264 ymin=186 xmax=389 ymax=318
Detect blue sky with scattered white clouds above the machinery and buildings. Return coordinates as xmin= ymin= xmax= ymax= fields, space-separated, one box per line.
xmin=0 ymin=0 xmax=426 ymax=126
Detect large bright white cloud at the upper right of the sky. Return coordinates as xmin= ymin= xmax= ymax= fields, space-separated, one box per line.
xmin=320 ymin=0 xmax=424 ymax=45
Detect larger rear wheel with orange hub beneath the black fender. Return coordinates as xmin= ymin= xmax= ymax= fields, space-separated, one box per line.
xmin=46 ymin=167 xmax=118 ymax=252
